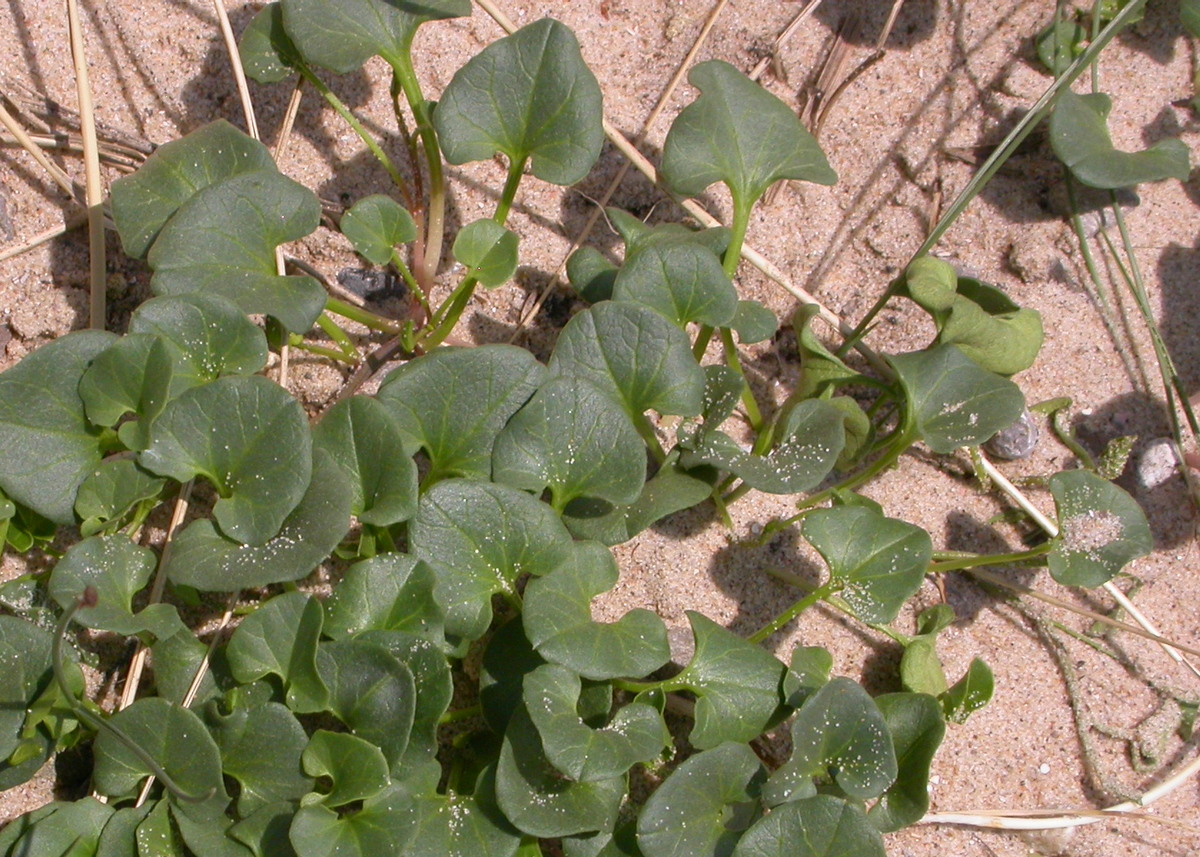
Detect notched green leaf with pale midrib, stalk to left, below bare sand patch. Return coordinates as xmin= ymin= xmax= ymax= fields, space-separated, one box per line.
xmin=670 ymin=610 xmax=784 ymax=750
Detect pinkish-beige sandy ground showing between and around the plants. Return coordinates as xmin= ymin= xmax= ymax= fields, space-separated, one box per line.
xmin=0 ymin=0 xmax=1200 ymax=857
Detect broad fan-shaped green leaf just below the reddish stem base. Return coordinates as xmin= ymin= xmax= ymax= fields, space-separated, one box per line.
xmin=379 ymin=344 xmax=545 ymax=485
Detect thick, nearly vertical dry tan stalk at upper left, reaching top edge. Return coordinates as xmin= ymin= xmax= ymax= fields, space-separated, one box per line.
xmin=67 ymin=0 xmax=108 ymax=330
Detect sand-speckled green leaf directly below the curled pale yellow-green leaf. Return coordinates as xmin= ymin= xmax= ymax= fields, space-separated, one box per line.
xmin=888 ymin=344 xmax=1025 ymax=454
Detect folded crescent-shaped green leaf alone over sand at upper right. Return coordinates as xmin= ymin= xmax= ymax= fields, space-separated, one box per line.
xmin=1050 ymin=89 xmax=1192 ymax=190
